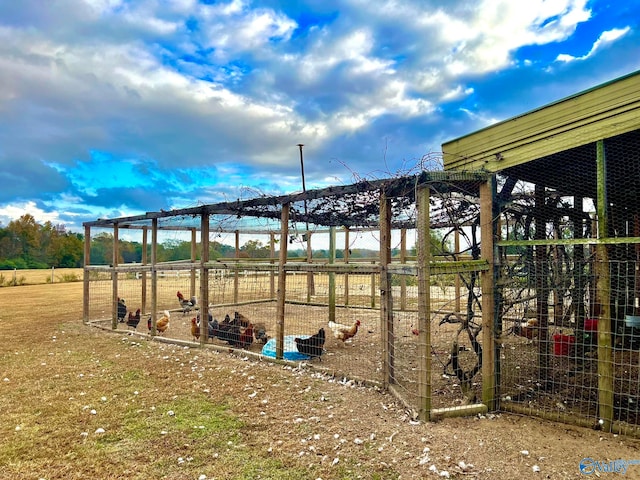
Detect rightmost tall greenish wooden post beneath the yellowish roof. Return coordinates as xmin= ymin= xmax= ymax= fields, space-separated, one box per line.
xmin=595 ymin=140 xmax=613 ymax=432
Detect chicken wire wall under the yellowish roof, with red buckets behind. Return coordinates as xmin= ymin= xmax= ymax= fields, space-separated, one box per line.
xmin=496 ymin=132 xmax=640 ymax=431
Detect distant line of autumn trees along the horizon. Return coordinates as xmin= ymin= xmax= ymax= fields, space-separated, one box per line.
xmin=0 ymin=213 xmax=398 ymax=270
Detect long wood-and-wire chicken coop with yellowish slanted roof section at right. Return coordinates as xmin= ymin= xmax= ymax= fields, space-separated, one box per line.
xmin=83 ymin=72 xmax=640 ymax=434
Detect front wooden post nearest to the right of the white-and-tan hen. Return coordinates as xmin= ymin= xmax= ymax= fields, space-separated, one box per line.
xmin=380 ymin=192 xmax=395 ymax=388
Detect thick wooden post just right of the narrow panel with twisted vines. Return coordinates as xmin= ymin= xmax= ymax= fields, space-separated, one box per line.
xmin=478 ymin=177 xmax=500 ymax=410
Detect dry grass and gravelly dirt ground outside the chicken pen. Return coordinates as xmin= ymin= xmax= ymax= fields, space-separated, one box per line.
xmin=0 ymin=270 xmax=640 ymax=480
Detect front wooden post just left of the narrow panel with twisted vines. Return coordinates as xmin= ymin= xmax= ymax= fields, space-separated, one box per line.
xmin=416 ymin=185 xmax=431 ymax=422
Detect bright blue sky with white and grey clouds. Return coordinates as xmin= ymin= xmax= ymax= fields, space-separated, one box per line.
xmin=0 ymin=0 xmax=640 ymax=231
